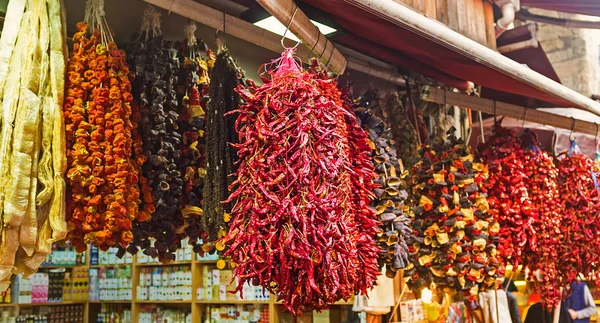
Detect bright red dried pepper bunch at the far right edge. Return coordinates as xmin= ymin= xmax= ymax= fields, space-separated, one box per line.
xmin=556 ymin=141 xmax=600 ymax=287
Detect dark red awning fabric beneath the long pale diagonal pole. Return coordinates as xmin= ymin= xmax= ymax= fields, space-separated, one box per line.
xmin=303 ymin=0 xmax=571 ymax=106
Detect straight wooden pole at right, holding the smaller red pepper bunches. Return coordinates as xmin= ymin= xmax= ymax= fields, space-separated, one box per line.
xmin=421 ymin=86 xmax=600 ymax=136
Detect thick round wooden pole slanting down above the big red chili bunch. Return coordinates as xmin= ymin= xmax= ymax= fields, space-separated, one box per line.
xmin=257 ymin=0 xmax=346 ymax=75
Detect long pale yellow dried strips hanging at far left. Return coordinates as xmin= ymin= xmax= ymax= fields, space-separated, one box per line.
xmin=0 ymin=0 xmax=67 ymax=291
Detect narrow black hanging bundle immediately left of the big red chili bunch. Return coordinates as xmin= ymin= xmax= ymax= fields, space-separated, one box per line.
xmin=202 ymin=51 xmax=240 ymax=241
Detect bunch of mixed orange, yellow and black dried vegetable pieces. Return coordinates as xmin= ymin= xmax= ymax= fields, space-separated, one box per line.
xmin=404 ymin=129 xmax=501 ymax=301
